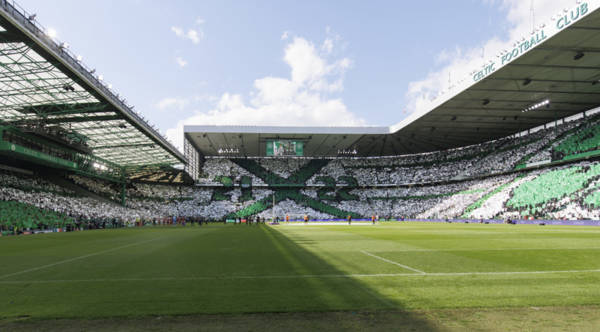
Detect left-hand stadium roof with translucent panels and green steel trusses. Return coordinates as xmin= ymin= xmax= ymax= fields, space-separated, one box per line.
xmin=0 ymin=0 xmax=185 ymax=167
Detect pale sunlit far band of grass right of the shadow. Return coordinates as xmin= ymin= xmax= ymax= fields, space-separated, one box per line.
xmin=278 ymin=223 xmax=600 ymax=252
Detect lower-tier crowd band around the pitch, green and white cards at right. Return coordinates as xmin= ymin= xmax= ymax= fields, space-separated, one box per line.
xmin=0 ymin=158 xmax=600 ymax=231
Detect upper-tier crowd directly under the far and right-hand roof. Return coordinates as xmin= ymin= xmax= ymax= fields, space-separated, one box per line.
xmin=191 ymin=116 xmax=599 ymax=186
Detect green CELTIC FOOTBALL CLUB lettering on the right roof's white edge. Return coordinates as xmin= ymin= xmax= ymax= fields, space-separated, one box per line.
xmin=473 ymin=2 xmax=589 ymax=82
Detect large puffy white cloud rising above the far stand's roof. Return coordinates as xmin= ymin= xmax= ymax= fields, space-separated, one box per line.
xmin=167 ymin=37 xmax=365 ymax=148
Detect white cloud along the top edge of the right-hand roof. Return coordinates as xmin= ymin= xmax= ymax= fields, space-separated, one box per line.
xmin=406 ymin=0 xmax=575 ymax=113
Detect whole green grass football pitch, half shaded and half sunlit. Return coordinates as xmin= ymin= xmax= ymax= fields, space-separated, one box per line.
xmin=0 ymin=223 xmax=600 ymax=330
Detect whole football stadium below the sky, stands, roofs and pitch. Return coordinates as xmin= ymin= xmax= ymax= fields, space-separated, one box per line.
xmin=0 ymin=0 xmax=600 ymax=331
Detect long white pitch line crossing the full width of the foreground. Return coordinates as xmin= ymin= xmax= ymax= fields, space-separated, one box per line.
xmin=0 ymin=269 xmax=600 ymax=284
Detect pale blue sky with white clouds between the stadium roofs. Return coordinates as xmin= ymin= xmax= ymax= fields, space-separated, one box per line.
xmin=18 ymin=0 xmax=576 ymax=148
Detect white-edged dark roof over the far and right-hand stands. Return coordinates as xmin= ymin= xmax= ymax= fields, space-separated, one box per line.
xmin=184 ymin=0 xmax=600 ymax=156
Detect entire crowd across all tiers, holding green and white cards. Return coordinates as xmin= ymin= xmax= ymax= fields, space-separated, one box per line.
xmin=0 ymin=110 xmax=600 ymax=230
